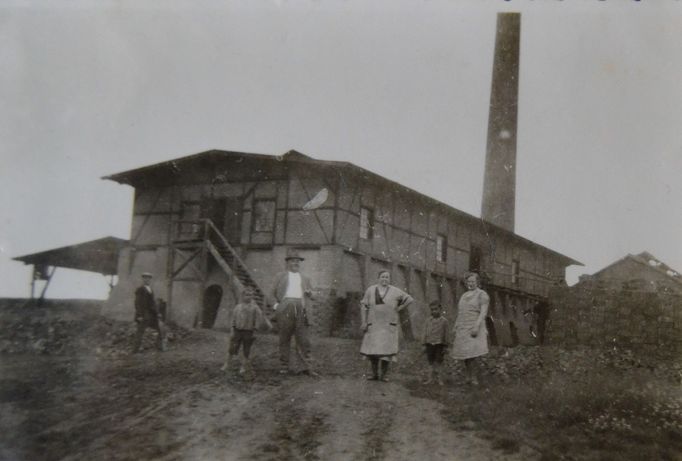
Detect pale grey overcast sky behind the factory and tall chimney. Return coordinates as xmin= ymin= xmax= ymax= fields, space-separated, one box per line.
xmin=0 ymin=0 xmax=682 ymax=298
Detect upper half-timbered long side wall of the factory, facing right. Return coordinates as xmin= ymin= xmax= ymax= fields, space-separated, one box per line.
xmin=336 ymin=174 xmax=564 ymax=296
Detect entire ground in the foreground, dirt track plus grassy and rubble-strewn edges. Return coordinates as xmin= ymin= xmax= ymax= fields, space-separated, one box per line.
xmin=5 ymin=300 xmax=682 ymax=461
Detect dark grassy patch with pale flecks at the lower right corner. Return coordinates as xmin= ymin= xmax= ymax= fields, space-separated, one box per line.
xmin=408 ymin=351 xmax=682 ymax=460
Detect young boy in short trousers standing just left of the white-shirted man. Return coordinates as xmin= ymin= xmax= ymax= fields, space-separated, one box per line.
xmin=221 ymin=288 xmax=272 ymax=378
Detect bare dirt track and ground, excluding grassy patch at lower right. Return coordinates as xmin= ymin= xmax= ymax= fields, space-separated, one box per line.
xmin=0 ymin=320 xmax=539 ymax=460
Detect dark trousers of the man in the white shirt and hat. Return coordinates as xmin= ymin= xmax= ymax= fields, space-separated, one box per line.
xmin=277 ymin=298 xmax=311 ymax=370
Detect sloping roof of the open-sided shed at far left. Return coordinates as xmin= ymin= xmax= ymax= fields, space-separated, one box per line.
xmin=13 ymin=237 xmax=129 ymax=275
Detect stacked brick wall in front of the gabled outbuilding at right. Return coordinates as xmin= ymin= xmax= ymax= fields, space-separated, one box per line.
xmin=546 ymin=284 xmax=682 ymax=358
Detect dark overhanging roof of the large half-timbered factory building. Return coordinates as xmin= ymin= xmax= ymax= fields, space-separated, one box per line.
xmin=102 ymin=149 xmax=583 ymax=266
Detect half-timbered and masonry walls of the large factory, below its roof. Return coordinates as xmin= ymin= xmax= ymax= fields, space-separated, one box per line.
xmin=103 ymin=157 xmax=564 ymax=343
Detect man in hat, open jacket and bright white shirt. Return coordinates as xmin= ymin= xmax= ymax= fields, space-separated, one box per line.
xmin=272 ymin=248 xmax=315 ymax=376
